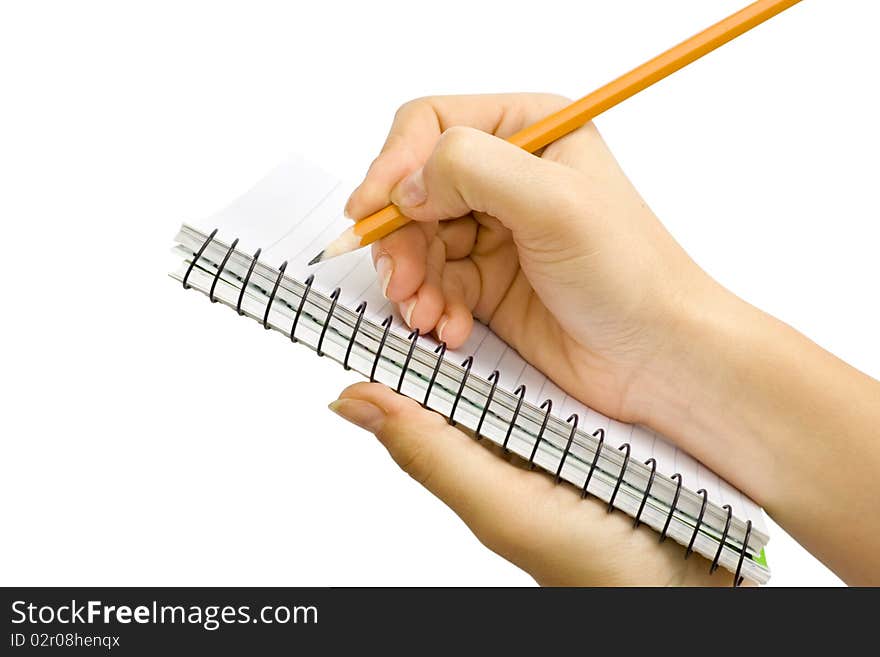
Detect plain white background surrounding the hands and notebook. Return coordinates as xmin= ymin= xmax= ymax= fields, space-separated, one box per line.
xmin=0 ymin=0 xmax=880 ymax=585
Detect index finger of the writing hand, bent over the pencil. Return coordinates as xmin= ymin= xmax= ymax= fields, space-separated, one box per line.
xmin=346 ymin=94 xmax=568 ymax=219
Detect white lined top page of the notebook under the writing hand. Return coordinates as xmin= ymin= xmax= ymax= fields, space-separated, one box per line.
xmin=188 ymin=157 xmax=767 ymax=535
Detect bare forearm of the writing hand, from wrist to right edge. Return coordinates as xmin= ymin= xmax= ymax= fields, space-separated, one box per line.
xmin=633 ymin=283 xmax=880 ymax=584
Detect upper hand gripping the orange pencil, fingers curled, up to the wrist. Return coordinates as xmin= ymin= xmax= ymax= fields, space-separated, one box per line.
xmin=347 ymin=94 xmax=716 ymax=421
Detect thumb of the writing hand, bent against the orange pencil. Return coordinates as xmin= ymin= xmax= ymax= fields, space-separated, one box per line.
xmin=391 ymin=127 xmax=582 ymax=238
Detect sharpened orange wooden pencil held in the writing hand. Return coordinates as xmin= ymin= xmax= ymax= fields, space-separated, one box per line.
xmin=309 ymin=0 xmax=800 ymax=265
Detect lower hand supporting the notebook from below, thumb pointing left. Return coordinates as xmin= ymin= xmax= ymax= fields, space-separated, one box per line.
xmin=330 ymin=383 xmax=733 ymax=586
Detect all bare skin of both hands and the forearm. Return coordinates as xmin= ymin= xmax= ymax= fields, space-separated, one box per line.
xmin=331 ymin=94 xmax=880 ymax=585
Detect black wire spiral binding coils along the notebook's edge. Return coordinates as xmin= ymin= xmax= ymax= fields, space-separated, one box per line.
xmin=182 ymin=228 xmax=752 ymax=587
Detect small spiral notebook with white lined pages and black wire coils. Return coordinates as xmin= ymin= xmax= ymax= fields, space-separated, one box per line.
xmin=171 ymin=157 xmax=770 ymax=584
